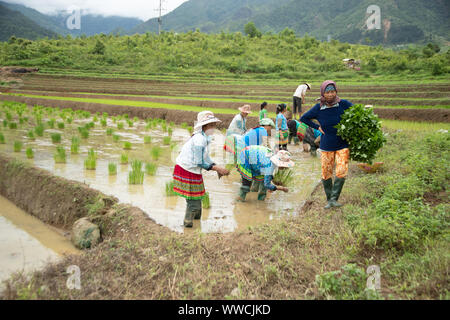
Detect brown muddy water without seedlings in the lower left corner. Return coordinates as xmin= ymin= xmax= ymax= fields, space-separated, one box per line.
xmin=0 ymin=196 xmax=79 ymax=291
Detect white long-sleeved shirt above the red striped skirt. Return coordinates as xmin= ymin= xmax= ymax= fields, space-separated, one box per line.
xmin=176 ymin=131 xmax=214 ymax=174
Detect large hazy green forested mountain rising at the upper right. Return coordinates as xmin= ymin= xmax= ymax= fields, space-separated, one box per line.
xmin=131 ymin=0 xmax=450 ymax=44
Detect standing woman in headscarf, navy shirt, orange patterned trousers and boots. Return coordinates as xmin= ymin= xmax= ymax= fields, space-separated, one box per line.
xmin=300 ymin=80 xmax=352 ymax=209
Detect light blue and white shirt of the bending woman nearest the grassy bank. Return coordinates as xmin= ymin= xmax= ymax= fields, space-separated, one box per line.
xmin=238 ymin=146 xmax=277 ymax=191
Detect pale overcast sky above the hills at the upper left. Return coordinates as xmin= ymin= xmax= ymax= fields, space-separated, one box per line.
xmin=3 ymin=0 xmax=187 ymax=20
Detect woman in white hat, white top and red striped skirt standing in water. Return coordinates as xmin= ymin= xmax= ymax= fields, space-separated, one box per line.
xmin=173 ymin=111 xmax=230 ymax=228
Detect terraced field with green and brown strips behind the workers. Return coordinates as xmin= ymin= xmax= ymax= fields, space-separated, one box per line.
xmin=2 ymin=74 xmax=450 ymax=125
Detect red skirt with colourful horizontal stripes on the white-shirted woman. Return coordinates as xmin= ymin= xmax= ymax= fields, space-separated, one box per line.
xmin=173 ymin=165 xmax=205 ymax=200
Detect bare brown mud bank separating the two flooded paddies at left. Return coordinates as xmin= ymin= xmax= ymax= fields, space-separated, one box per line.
xmin=0 ymin=154 xmax=118 ymax=229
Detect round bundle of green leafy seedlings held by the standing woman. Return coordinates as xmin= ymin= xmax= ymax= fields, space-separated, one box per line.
xmin=335 ymin=104 xmax=386 ymax=164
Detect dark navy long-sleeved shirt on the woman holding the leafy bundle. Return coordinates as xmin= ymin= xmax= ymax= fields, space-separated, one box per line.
xmin=300 ymin=100 xmax=353 ymax=151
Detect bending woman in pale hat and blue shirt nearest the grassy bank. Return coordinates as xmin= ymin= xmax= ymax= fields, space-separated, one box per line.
xmin=236 ymin=146 xmax=294 ymax=202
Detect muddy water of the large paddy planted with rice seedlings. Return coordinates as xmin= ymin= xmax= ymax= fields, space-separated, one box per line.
xmin=0 ymin=116 xmax=320 ymax=233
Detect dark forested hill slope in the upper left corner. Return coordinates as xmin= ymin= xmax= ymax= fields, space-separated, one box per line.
xmin=0 ymin=4 xmax=57 ymax=41
